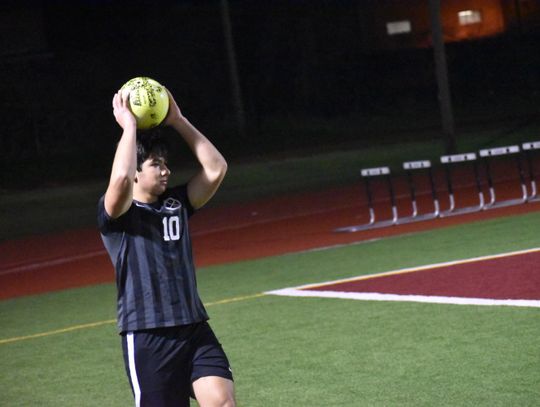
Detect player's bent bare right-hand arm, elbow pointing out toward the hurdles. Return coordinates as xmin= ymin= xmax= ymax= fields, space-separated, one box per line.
xmin=165 ymin=92 xmax=227 ymax=209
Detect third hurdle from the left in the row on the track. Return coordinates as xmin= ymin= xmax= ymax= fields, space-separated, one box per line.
xmin=439 ymin=153 xmax=484 ymax=217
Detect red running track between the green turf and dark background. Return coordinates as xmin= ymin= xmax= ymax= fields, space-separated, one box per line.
xmin=0 ymin=185 xmax=540 ymax=299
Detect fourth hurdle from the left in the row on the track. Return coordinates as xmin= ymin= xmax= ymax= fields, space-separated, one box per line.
xmin=479 ymin=145 xmax=527 ymax=209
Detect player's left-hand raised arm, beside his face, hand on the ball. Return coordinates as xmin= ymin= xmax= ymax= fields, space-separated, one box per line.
xmin=105 ymin=91 xmax=137 ymax=218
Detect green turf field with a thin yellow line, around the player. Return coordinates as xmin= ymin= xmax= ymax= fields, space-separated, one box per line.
xmin=0 ymin=212 xmax=540 ymax=407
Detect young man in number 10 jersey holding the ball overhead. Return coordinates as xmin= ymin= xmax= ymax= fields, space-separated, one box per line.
xmin=98 ymin=87 xmax=235 ymax=407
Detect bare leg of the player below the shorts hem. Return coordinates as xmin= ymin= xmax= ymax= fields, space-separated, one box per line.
xmin=193 ymin=376 xmax=236 ymax=407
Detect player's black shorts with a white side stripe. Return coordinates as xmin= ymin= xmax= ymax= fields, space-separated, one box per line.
xmin=122 ymin=322 xmax=233 ymax=407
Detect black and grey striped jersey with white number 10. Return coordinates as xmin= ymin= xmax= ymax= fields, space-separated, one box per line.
xmin=98 ymin=185 xmax=208 ymax=332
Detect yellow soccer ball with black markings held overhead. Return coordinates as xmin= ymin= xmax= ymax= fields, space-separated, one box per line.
xmin=122 ymin=76 xmax=169 ymax=130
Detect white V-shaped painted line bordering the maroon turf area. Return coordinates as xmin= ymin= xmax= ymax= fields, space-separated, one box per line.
xmin=265 ymin=247 xmax=540 ymax=308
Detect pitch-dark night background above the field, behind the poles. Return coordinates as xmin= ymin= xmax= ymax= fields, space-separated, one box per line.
xmin=0 ymin=0 xmax=540 ymax=190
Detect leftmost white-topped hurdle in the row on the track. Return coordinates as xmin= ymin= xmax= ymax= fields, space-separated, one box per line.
xmin=334 ymin=167 xmax=398 ymax=232
